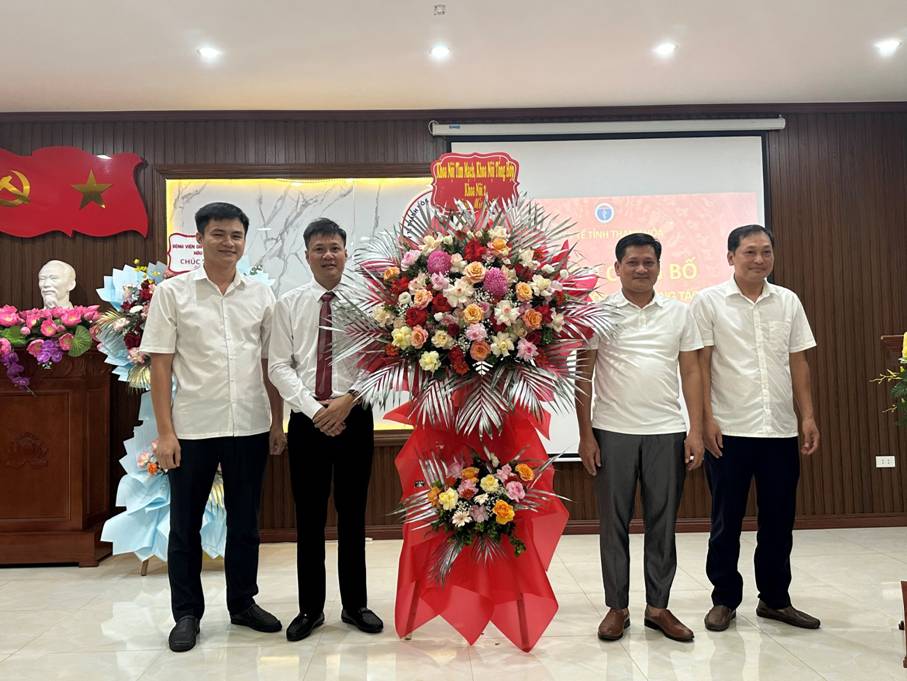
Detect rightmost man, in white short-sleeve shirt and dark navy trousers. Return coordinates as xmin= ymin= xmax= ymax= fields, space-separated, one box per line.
xmin=692 ymin=225 xmax=819 ymax=631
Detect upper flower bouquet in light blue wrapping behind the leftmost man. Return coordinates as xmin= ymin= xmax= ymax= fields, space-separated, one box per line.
xmin=95 ymin=260 xmax=166 ymax=390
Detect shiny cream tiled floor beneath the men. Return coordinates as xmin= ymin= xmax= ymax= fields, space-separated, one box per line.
xmin=0 ymin=528 xmax=907 ymax=681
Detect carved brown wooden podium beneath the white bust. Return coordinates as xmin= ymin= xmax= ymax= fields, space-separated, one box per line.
xmin=0 ymin=350 xmax=110 ymax=567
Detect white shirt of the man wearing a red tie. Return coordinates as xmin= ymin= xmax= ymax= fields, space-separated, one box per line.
xmin=268 ymin=279 xmax=359 ymax=418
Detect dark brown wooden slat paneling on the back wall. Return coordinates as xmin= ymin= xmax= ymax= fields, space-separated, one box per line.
xmin=0 ymin=104 xmax=907 ymax=536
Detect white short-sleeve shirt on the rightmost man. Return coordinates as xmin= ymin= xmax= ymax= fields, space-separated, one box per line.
xmin=692 ymin=277 xmax=816 ymax=437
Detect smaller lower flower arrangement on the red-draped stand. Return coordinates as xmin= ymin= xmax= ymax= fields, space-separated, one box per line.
xmin=399 ymin=450 xmax=556 ymax=583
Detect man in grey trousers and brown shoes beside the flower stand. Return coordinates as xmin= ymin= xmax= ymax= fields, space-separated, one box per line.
xmin=576 ymin=234 xmax=704 ymax=641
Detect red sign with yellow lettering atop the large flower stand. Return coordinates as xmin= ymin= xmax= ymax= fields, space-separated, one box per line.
xmin=431 ymin=152 xmax=520 ymax=210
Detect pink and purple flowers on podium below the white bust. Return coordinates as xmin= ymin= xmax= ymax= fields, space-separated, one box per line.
xmin=0 ymin=305 xmax=98 ymax=390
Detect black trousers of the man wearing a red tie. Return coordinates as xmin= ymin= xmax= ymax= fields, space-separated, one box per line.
xmin=287 ymin=405 xmax=374 ymax=615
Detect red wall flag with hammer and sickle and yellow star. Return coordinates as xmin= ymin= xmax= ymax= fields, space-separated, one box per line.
xmin=0 ymin=147 xmax=148 ymax=237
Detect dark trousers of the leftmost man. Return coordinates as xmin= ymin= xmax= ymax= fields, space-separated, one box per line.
xmin=167 ymin=433 xmax=268 ymax=621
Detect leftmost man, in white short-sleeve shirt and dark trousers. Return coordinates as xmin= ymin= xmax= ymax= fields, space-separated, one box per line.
xmin=141 ymin=203 xmax=286 ymax=652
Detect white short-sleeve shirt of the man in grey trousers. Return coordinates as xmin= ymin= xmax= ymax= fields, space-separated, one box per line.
xmin=589 ymin=291 xmax=702 ymax=435
